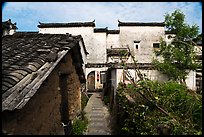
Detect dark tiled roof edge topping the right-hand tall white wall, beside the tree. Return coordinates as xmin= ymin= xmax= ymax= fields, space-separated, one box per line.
xmin=118 ymin=20 xmax=165 ymax=26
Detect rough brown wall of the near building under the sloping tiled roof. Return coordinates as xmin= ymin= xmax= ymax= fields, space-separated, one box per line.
xmin=2 ymin=54 xmax=81 ymax=135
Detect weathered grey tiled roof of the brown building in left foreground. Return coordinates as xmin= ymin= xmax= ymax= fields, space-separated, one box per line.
xmin=2 ymin=33 xmax=85 ymax=111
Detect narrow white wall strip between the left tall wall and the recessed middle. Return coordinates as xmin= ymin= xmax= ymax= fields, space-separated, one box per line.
xmin=93 ymin=32 xmax=107 ymax=63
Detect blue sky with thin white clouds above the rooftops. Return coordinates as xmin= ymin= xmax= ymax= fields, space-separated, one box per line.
xmin=2 ymin=2 xmax=202 ymax=32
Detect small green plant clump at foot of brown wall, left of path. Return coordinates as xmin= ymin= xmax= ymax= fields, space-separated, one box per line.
xmin=72 ymin=112 xmax=88 ymax=135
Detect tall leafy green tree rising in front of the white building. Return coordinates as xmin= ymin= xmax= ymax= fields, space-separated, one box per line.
xmin=153 ymin=10 xmax=199 ymax=84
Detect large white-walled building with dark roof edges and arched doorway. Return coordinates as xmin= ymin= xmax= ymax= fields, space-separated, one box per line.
xmin=38 ymin=21 xmax=196 ymax=90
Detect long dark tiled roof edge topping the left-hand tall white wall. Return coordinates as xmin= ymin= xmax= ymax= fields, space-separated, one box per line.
xmin=38 ymin=21 xmax=95 ymax=28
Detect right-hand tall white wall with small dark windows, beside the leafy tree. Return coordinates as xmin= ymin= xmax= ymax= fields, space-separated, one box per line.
xmin=119 ymin=26 xmax=165 ymax=63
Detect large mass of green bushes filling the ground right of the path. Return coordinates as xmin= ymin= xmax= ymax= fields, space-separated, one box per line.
xmin=117 ymin=80 xmax=202 ymax=135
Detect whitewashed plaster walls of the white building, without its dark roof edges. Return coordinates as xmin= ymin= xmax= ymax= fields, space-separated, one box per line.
xmin=39 ymin=23 xmax=196 ymax=89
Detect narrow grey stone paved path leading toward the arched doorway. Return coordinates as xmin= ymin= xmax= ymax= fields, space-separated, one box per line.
xmin=84 ymin=93 xmax=111 ymax=135
